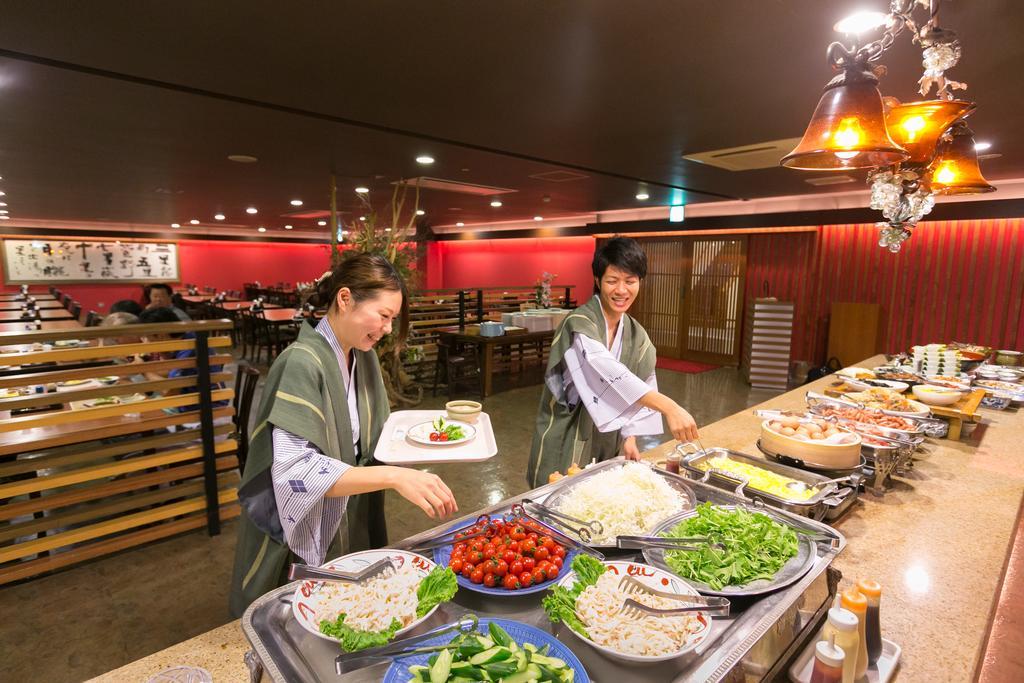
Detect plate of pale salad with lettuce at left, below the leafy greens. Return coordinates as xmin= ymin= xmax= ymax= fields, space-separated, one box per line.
xmin=544 ymin=555 xmax=712 ymax=664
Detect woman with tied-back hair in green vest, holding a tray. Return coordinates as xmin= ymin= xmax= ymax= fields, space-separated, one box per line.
xmin=230 ymin=254 xmax=458 ymax=616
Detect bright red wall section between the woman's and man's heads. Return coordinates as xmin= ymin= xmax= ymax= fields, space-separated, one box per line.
xmin=426 ymin=237 xmax=594 ymax=303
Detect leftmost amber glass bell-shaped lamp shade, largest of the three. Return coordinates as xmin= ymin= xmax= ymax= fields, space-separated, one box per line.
xmin=781 ymin=72 xmax=909 ymax=171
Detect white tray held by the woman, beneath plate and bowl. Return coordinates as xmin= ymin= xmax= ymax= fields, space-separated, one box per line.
xmin=374 ymin=410 xmax=498 ymax=465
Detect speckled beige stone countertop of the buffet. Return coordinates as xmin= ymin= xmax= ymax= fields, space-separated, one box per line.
xmin=94 ymin=356 xmax=1024 ymax=683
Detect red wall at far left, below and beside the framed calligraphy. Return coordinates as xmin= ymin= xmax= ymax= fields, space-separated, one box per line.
xmin=3 ymin=240 xmax=330 ymax=313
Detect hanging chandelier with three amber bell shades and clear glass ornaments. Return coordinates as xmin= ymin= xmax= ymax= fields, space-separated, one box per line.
xmin=781 ymin=0 xmax=995 ymax=253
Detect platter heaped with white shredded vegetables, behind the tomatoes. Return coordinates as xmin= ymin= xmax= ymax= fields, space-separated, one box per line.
xmin=544 ymin=460 xmax=696 ymax=550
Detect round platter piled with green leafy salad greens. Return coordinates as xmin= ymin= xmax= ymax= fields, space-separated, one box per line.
xmin=643 ymin=503 xmax=816 ymax=597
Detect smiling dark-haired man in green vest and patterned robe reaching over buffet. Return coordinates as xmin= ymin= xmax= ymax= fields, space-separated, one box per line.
xmin=526 ymin=238 xmax=697 ymax=486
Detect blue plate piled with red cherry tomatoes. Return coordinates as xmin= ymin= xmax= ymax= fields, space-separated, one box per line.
xmin=434 ymin=511 xmax=579 ymax=596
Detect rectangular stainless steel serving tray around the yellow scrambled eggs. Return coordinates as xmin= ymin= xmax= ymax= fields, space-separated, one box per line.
xmin=681 ymin=447 xmax=840 ymax=519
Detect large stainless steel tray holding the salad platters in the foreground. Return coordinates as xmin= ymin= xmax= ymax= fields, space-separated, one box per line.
xmin=242 ymin=461 xmax=846 ymax=683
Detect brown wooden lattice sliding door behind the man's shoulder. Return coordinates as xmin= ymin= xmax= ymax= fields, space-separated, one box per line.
xmin=630 ymin=237 xmax=746 ymax=365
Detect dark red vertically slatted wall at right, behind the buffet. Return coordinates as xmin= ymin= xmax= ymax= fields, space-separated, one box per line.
xmin=746 ymin=218 xmax=1024 ymax=361
